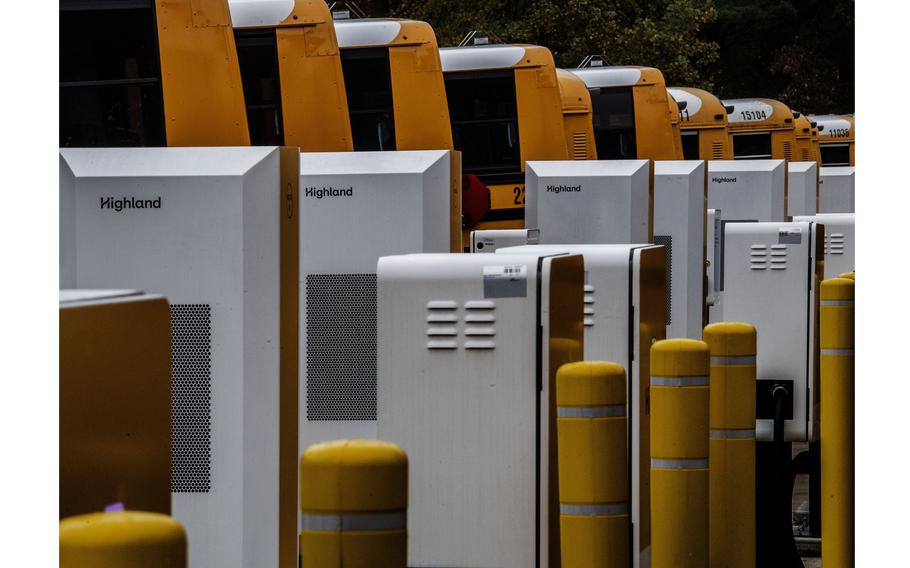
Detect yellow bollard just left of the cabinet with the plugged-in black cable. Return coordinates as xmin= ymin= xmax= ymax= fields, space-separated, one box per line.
xmin=704 ymin=323 xmax=756 ymax=568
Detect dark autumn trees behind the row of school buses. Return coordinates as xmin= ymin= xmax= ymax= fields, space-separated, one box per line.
xmin=338 ymin=0 xmax=854 ymax=113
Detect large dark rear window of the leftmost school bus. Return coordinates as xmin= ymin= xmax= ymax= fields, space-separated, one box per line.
xmin=60 ymin=0 xmax=165 ymax=147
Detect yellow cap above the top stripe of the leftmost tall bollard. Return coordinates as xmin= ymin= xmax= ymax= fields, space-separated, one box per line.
xmin=556 ymin=361 xmax=626 ymax=406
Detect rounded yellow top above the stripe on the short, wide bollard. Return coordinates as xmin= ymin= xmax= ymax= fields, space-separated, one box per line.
xmin=300 ymin=440 xmax=408 ymax=513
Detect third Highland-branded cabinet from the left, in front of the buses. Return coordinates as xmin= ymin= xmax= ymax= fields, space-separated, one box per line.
xmin=525 ymin=160 xmax=653 ymax=244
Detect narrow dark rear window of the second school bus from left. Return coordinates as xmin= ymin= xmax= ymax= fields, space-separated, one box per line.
xmin=234 ymin=29 xmax=284 ymax=146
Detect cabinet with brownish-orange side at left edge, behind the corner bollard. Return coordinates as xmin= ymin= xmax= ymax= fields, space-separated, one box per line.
xmin=59 ymin=290 xmax=171 ymax=519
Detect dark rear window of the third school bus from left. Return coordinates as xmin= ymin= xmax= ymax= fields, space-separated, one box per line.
xmin=341 ymin=47 xmax=395 ymax=151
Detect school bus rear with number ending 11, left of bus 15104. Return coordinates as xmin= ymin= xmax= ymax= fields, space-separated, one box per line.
xmin=667 ymin=87 xmax=733 ymax=160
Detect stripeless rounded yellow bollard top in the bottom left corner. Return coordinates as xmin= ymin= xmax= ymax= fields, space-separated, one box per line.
xmin=60 ymin=511 xmax=186 ymax=568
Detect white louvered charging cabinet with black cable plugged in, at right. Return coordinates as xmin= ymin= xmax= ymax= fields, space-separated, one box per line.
xmin=721 ymin=222 xmax=825 ymax=442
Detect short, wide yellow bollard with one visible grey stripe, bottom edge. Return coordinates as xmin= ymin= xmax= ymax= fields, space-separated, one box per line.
xmin=300 ymin=440 xmax=408 ymax=568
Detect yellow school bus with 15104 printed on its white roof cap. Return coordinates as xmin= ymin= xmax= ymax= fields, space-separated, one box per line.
xmin=723 ymin=99 xmax=797 ymax=162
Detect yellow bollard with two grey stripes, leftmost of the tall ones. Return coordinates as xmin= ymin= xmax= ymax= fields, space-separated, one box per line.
xmin=556 ymin=361 xmax=632 ymax=568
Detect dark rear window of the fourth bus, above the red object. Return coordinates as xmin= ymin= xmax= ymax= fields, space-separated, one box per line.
xmin=445 ymin=69 xmax=523 ymax=184
